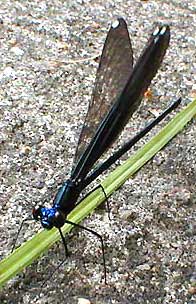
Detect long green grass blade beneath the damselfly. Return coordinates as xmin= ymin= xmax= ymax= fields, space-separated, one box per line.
xmin=0 ymin=100 xmax=196 ymax=286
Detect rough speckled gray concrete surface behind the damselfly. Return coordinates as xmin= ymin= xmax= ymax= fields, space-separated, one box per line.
xmin=0 ymin=0 xmax=196 ymax=304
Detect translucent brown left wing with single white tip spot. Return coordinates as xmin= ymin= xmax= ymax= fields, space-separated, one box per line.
xmin=74 ymin=18 xmax=133 ymax=171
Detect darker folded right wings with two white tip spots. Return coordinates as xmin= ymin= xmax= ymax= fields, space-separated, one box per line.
xmin=71 ymin=26 xmax=170 ymax=185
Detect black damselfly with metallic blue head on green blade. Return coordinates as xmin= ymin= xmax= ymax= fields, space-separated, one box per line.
xmin=13 ymin=18 xmax=180 ymax=278
